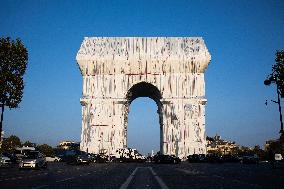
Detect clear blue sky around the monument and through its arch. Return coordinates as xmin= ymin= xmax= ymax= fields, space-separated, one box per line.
xmin=0 ymin=0 xmax=284 ymax=153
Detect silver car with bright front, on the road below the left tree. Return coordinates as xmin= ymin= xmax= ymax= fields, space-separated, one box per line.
xmin=19 ymin=151 xmax=47 ymax=169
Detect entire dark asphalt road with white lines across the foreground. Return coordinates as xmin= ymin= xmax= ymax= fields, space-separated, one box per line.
xmin=0 ymin=162 xmax=284 ymax=189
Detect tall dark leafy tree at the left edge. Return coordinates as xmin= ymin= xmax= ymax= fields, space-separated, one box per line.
xmin=0 ymin=37 xmax=28 ymax=139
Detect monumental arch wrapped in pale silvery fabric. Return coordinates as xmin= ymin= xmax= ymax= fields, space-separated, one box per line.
xmin=76 ymin=37 xmax=211 ymax=158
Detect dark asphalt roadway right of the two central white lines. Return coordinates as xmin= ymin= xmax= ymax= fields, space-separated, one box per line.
xmin=154 ymin=162 xmax=283 ymax=188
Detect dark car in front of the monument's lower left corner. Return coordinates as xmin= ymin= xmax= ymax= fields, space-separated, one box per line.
xmin=64 ymin=150 xmax=92 ymax=165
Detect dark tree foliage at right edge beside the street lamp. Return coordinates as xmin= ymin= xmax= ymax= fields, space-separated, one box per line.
xmin=265 ymin=50 xmax=284 ymax=98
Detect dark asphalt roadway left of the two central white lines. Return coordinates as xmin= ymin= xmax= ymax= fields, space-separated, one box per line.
xmin=0 ymin=164 xmax=139 ymax=188
